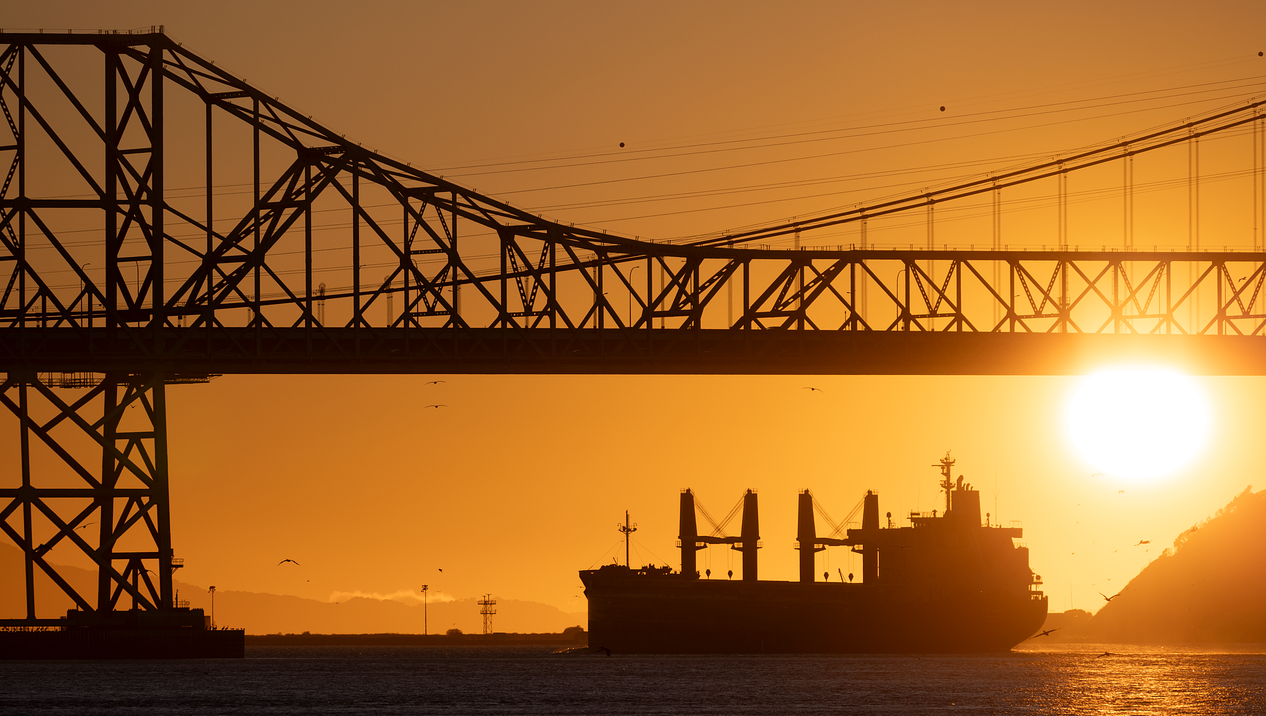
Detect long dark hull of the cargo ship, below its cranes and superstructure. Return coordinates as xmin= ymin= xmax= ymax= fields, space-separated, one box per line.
xmin=581 ymin=567 xmax=1047 ymax=654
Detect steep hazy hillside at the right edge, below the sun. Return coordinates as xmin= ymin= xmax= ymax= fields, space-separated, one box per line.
xmin=1087 ymin=486 xmax=1266 ymax=644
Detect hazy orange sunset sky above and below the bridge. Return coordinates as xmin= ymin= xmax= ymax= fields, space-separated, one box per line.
xmin=4 ymin=1 xmax=1266 ymax=622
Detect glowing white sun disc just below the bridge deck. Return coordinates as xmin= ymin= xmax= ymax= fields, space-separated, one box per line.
xmin=1069 ymin=369 xmax=1209 ymax=479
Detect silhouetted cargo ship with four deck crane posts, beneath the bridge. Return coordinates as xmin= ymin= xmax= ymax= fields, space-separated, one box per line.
xmin=580 ymin=454 xmax=1047 ymax=654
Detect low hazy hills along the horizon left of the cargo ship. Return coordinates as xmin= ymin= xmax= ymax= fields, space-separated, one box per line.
xmin=0 ymin=541 xmax=587 ymax=634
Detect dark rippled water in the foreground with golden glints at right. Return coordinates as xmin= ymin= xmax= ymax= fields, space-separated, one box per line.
xmin=0 ymin=644 xmax=1266 ymax=715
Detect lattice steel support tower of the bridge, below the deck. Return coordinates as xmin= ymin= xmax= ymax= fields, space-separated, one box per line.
xmin=0 ymin=372 xmax=180 ymax=625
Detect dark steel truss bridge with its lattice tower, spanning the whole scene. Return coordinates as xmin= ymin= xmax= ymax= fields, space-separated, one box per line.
xmin=0 ymin=28 xmax=1266 ymax=626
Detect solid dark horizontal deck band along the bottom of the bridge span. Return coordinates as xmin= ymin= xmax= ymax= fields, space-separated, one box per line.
xmin=0 ymin=328 xmax=1266 ymax=376
